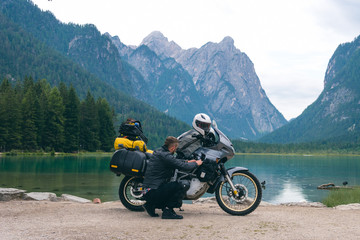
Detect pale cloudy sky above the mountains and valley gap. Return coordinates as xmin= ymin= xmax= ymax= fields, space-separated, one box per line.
xmin=33 ymin=0 xmax=360 ymax=120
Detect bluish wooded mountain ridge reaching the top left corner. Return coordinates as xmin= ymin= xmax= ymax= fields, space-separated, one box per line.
xmin=0 ymin=0 xmax=147 ymax=93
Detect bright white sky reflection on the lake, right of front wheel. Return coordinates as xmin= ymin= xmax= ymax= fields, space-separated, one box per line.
xmin=269 ymin=182 xmax=307 ymax=204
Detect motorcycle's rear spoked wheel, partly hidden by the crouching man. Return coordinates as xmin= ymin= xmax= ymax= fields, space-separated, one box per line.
xmin=119 ymin=176 xmax=145 ymax=212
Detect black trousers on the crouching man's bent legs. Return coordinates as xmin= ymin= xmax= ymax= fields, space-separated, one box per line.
xmin=145 ymin=182 xmax=185 ymax=209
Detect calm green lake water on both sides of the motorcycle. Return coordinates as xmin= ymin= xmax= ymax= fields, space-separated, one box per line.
xmin=0 ymin=155 xmax=360 ymax=203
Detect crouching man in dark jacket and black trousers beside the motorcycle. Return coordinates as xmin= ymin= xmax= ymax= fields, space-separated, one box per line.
xmin=143 ymin=136 xmax=202 ymax=219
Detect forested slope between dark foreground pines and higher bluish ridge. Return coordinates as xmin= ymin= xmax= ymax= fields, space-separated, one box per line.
xmin=0 ymin=9 xmax=189 ymax=148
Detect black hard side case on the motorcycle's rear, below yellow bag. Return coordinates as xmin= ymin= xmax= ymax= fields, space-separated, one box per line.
xmin=110 ymin=148 xmax=148 ymax=176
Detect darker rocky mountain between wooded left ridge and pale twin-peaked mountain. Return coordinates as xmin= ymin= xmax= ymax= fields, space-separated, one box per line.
xmin=107 ymin=34 xmax=205 ymax=122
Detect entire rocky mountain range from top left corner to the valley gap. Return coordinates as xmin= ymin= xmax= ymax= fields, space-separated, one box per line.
xmin=0 ymin=0 xmax=286 ymax=139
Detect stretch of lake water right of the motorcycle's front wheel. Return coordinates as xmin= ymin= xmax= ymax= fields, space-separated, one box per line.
xmin=226 ymin=155 xmax=360 ymax=203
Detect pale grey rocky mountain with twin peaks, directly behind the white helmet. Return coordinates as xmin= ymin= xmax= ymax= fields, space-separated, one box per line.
xmin=136 ymin=32 xmax=287 ymax=139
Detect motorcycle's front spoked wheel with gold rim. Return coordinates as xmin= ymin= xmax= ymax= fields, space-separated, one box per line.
xmin=215 ymin=171 xmax=262 ymax=216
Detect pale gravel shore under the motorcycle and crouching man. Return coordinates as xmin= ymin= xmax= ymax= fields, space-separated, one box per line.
xmin=0 ymin=201 xmax=360 ymax=240
